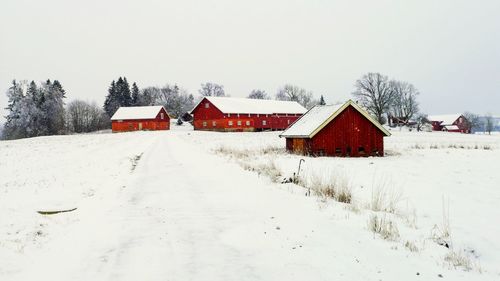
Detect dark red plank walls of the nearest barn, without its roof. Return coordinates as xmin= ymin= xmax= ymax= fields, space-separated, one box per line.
xmin=286 ymin=106 xmax=384 ymax=157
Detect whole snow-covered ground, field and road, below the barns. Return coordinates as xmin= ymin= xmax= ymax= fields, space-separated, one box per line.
xmin=0 ymin=125 xmax=500 ymax=280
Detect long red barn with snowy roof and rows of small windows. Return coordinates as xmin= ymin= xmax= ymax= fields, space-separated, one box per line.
xmin=191 ymin=97 xmax=307 ymax=132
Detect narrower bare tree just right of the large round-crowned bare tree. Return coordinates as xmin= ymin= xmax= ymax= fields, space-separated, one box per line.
xmin=389 ymin=80 xmax=419 ymax=125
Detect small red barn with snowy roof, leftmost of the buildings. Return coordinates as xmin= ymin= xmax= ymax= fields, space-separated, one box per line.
xmin=111 ymin=106 xmax=170 ymax=132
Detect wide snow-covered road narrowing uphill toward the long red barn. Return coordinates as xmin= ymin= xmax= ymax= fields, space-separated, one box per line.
xmin=1 ymin=131 xmax=488 ymax=280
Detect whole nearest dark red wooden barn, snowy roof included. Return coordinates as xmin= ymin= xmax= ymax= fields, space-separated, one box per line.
xmin=280 ymin=100 xmax=391 ymax=157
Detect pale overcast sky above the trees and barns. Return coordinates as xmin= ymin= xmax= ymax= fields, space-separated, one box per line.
xmin=0 ymin=0 xmax=500 ymax=120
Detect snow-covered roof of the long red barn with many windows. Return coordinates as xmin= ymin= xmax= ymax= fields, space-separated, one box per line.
xmin=191 ymin=97 xmax=307 ymax=114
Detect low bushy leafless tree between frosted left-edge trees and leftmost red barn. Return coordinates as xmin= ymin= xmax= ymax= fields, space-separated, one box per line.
xmin=66 ymin=100 xmax=110 ymax=133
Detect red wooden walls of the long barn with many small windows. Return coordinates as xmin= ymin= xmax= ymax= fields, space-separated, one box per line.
xmin=193 ymin=99 xmax=302 ymax=132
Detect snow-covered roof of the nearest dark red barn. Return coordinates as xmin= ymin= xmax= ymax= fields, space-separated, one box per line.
xmin=280 ymin=100 xmax=391 ymax=138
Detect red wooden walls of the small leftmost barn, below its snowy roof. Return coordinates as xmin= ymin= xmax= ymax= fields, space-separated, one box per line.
xmin=111 ymin=108 xmax=170 ymax=132
